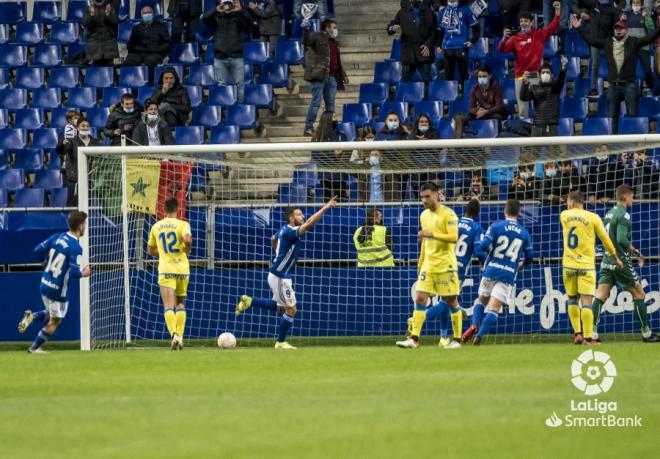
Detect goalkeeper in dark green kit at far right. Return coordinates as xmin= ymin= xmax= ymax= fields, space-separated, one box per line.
xmin=592 ymin=185 xmax=660 ymax=343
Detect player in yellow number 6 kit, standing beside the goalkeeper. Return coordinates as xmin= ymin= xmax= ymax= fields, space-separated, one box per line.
xmin=559 ymin=191 xmax=623 ymax=344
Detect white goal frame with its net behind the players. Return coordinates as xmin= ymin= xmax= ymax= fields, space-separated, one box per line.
xmin=79 ymin=135 xmax=660 ymax=349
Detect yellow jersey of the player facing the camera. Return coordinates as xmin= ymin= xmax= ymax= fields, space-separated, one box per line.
xmin=417 ymin=205 xmax=458 ymax=273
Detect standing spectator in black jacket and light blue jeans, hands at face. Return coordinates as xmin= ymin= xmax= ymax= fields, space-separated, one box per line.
xmin=202 ymin=0 xmax=252 ymax=102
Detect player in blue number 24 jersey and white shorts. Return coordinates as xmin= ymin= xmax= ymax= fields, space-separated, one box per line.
xmin=466 ymin=199 xmax=534 ymax=346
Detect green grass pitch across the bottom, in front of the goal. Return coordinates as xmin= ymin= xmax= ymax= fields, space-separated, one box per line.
xmin=0 ymin=342 xmax=660 ymax=459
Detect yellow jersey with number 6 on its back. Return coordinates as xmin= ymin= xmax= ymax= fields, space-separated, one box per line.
xmin=559 ymin=209 xmax=615 ymax=269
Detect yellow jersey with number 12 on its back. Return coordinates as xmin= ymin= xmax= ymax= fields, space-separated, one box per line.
xmin=149 ymin=218 xmax=192 ymax=274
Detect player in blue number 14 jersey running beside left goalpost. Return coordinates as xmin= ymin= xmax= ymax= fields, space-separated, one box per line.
xmin=18 ymin=211 xmax=90 ymax=354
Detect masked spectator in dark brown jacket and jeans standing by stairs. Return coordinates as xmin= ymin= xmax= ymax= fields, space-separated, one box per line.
xmin=303 ymin=19 xmax=348 ymax=136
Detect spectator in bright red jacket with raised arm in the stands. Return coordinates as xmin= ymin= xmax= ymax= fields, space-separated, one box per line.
xmin=499 ymin=2 xmax=560 ymax=119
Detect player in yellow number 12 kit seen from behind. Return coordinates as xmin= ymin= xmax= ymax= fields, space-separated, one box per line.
xmin=147 ymin=198 xmax=192 ymax=351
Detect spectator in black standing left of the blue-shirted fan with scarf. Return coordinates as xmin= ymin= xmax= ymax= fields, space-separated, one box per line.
xmin=387 ymin=0 xmax=438 ymax=94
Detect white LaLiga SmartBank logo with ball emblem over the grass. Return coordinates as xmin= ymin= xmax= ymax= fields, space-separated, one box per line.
xmin=545 ymin=349 xmax=642 ymax=428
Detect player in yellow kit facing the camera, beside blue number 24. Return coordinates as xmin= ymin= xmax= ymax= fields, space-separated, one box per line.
xmin=396 ymin=182 xmax=461 ymax=349
